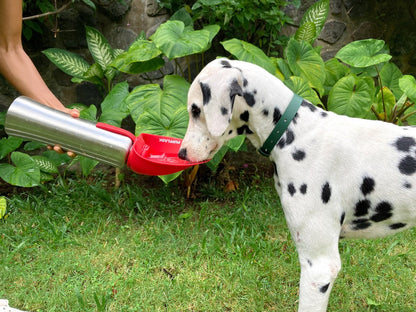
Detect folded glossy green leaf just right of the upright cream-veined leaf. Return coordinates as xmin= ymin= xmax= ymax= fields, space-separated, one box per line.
xmin=110 ymin=40 xmax=165 ymax=74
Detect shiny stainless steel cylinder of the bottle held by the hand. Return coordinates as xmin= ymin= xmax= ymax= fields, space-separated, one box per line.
xmin=5 ymin=96 xmax=133 ymax=167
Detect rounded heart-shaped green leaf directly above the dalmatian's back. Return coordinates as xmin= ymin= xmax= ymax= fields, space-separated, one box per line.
xmin=328 ymin=74 xmax=375 ymax=118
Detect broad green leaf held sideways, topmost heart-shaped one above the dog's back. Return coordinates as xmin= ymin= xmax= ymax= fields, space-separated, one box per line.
xmin=335 ymin=39 xmax=391 ymax=68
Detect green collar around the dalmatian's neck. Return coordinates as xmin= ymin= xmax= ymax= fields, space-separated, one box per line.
xmin=259 ymin=94 xmax=303 ymax=157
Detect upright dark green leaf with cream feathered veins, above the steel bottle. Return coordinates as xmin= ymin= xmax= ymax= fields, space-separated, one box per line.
xmin=85 ymin=26 xmax=114 ymax=71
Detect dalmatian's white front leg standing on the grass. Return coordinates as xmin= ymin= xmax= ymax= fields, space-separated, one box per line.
xmin=285 ymin=201 xmax=341 ymax=312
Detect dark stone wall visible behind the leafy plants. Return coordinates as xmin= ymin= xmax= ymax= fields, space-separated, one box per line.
xmin=0 ymin=0 xmax=416 ymax=110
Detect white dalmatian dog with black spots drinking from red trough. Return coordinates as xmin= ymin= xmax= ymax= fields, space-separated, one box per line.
xmin=179 ymin=59 xmax=416 ymax=312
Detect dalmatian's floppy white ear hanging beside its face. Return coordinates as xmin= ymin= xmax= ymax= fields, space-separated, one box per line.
xmin=204 ymin=79 xmax=243 ymax=137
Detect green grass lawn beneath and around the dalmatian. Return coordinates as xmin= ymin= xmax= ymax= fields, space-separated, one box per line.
xmin=0 ymin=168 xmax=416 ymax=312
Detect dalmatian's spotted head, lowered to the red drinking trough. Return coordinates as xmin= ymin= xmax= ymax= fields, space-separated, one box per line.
xmin=179 ymin=59 xmax=243 ymax=161
